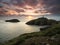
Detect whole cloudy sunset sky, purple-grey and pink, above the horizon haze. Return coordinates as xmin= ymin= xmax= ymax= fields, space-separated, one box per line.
xmin=0 ymin=0 xmax=60 ymax=15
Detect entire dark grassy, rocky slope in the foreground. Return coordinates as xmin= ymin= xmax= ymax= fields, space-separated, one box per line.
xmin=3 ymin=23 xmax=60 ymax=45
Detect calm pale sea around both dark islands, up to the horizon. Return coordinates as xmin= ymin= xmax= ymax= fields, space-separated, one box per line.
xmin=0 ymin=15 xmax=60 ymax=42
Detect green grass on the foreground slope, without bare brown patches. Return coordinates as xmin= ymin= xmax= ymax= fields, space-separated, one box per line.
xmin=4 ymin=23 xmax=60 ymax=45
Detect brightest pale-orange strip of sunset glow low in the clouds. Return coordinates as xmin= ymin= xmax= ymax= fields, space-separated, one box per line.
xmin=6 ymin=10 xmax=50 ymax=15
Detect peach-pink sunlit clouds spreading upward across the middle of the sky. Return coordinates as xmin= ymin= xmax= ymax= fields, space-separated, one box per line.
xmin=6 ymin=5 xmax=50 ymax=15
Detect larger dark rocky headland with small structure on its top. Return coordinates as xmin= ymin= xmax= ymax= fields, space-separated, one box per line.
xmin=26 ymin=17 xmax=58 ymax=26
